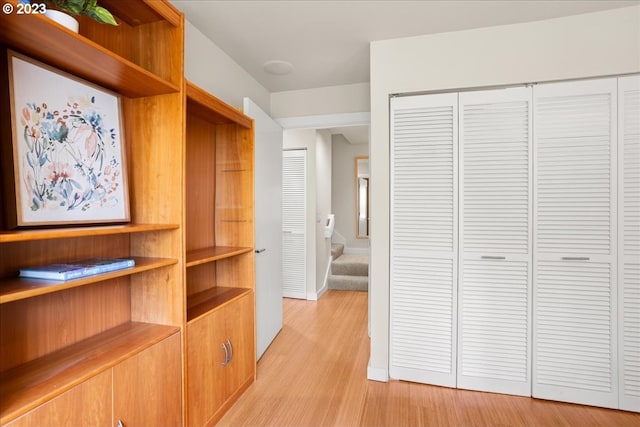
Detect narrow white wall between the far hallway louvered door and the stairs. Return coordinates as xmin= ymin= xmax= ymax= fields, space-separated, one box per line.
xmin=314 ymin=130 xmax=332 ymax=298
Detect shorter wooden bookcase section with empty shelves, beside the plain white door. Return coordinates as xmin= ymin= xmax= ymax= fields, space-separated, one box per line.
xmin=185 ymin=82 xmax=256 ymax=427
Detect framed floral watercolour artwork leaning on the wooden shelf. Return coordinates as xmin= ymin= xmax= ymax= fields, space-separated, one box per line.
xmin=8 ymin=51 xmax=129 ymax=227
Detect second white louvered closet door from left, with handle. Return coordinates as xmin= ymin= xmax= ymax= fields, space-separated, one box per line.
xmin=458 ymin=87 xmax=532 ymax=396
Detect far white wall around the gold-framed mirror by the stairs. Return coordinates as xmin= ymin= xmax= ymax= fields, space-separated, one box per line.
xmin=331 ymin=135 xmax=369 ymax=248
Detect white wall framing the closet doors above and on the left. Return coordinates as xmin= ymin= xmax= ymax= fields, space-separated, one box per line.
xmin=368 ymin=6 xmax=640 ymax=380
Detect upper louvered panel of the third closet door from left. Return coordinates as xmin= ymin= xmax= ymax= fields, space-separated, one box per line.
xmin=535 ymin=88 xmax=614 ymax=254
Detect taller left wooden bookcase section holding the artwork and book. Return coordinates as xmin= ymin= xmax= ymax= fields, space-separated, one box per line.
xmin=0 ymin=0 xmax=185 ymax=426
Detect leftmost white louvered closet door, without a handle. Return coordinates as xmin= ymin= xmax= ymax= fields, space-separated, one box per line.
xmin=389 ymin=94 xmax=458 ymax=387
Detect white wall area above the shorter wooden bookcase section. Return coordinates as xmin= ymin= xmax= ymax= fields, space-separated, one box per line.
xmin=184 ymin=20 xmax=271 ymax=113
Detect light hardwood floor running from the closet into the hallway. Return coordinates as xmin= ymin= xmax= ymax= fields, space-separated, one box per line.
xmin=218 ymin=291 xmax=640 ymax=427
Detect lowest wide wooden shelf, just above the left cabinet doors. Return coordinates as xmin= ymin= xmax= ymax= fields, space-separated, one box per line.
xmin=0 ymin=322 xmax=180 ymax=425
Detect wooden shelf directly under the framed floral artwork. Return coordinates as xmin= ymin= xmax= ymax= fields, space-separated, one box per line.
xmin=0 ymin=224 xmax=179 ymax=243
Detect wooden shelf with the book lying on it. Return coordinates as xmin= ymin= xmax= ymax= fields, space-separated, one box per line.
xmin=0 ymin=257 xmax=178 ymax=304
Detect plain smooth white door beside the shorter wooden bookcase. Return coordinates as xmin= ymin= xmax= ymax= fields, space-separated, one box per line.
xmin=243 ymin=98 xmax=282 ymax=359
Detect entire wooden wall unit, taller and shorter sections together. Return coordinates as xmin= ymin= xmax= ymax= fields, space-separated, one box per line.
xmin=0 ymin=0 xmax=255 ymax=427
